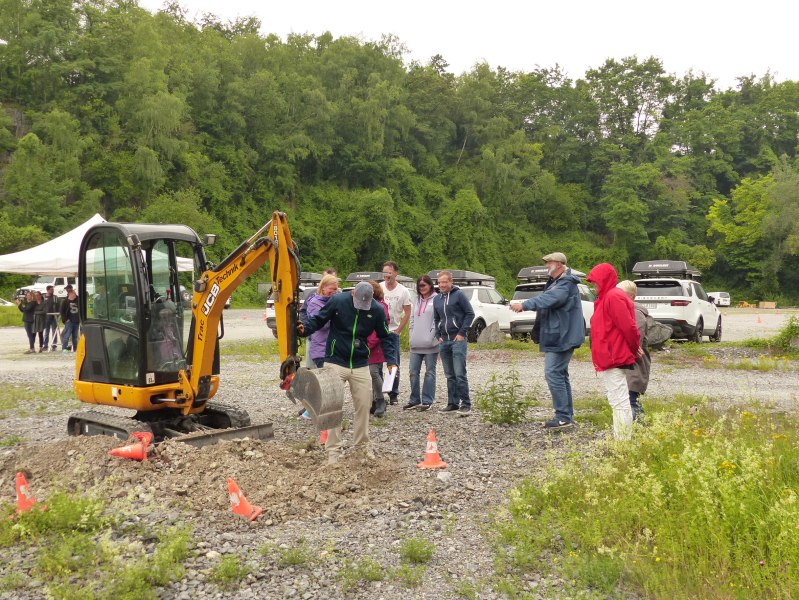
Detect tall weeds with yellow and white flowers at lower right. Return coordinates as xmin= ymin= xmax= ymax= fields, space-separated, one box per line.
xmin=500 ymin=406 xmax=799 ymax=598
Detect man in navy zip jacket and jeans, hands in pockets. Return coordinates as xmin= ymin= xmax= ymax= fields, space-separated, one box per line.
xmin=433 ymin=271 xmax=474 ymax=414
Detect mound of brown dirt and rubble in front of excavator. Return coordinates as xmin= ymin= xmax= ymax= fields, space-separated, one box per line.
xmin=0 ymin=436 xmax=447 ymax=528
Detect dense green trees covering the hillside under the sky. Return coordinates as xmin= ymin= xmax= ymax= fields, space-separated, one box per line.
xmin=0 ymin=0 xmax=799 ymax=298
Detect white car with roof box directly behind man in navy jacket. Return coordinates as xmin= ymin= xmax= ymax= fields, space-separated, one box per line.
xmin=428 ymin=269 xmax=517 ymax=342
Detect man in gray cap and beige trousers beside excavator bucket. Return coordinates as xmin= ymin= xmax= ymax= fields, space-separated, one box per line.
xmin=297 ymin=281 xmax=397 ymax=464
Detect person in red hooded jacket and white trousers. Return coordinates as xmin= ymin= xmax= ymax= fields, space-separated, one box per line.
xmin=586 ymin=263 xmax=643 ymax=440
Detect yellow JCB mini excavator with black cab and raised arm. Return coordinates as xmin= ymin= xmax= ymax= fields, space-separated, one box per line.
xmin=68 ymin=212 xmax=343 ymax=446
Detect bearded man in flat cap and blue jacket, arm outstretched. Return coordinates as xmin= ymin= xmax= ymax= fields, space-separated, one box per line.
xmin=511 ymin=252 xmax=585 ymax=430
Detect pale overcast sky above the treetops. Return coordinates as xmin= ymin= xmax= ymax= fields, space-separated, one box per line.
xmin=139 ymin=0 xmax=799 ymax=88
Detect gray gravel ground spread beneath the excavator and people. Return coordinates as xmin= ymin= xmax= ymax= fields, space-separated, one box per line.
xmin=0 ymin=309 xmax=799 ymax=599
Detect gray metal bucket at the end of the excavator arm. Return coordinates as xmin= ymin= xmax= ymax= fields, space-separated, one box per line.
xmin=289 ymin=367 xmax=344 ymax=432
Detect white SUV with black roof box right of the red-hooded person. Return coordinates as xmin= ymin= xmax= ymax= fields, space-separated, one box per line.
xmin=633 ymin=260 xmax=721 ymax=342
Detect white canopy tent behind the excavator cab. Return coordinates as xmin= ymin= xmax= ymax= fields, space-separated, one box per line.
xmin=0 ymin=214 xmax=194 ymax=276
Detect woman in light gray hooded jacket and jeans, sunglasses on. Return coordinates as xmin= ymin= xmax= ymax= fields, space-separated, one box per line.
xmin=402 ymin=275 xmax=438 ymax=411
